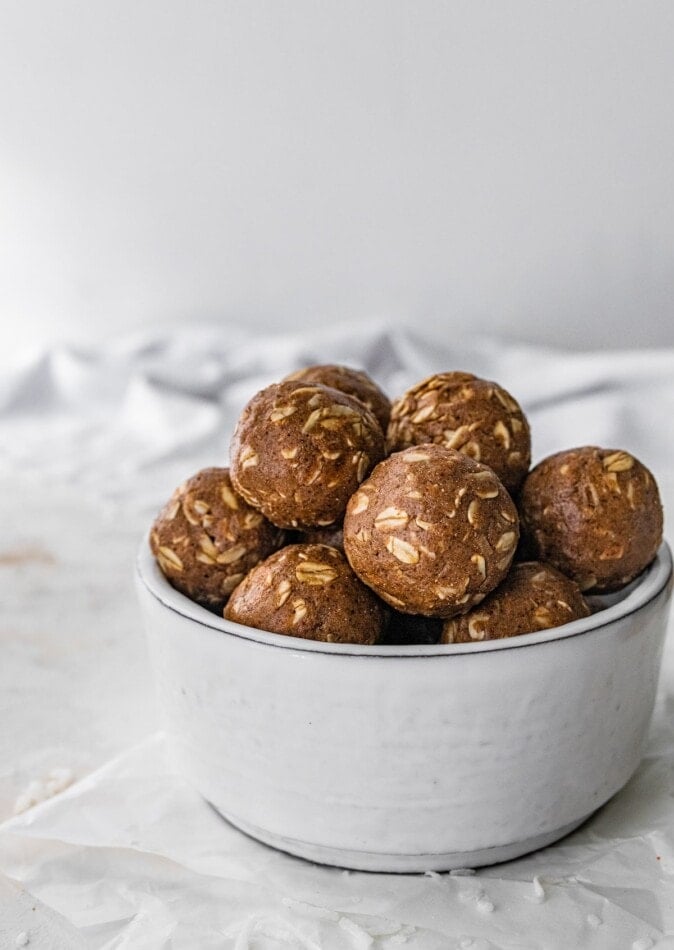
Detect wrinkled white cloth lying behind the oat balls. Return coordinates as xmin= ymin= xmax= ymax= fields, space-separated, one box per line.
xmin=5 ymin=326 xmax=674 ymax=504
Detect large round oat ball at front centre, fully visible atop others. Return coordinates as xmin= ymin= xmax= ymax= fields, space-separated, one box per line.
xmin=344 ymin=445 xmax=519 ymax=618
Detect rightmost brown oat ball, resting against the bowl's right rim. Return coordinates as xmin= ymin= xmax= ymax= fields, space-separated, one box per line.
xmin=520 ymin=445 xmax=663 ymax=594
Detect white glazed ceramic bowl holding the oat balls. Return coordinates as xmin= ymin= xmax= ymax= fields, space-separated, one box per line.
xmin=138 ymin=542 xmax=672 ymax=871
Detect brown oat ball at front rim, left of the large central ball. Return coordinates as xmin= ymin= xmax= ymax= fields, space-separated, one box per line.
xmin=225 ymin=544 xmax=388 ymax=643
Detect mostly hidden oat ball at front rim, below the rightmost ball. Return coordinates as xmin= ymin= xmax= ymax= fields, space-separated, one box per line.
xmin=442 ymin=561 xmax=590 ymax=643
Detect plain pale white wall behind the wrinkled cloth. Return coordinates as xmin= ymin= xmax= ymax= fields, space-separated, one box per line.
xmin=0 ymin=0 xmax=674 ymax=351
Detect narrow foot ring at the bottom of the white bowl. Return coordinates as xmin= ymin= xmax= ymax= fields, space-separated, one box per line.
xmin=213 ymin=806 xmax=592 ymax=874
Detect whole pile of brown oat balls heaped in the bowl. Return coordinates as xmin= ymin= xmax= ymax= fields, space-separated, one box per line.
xmin=150 ymin=365 xmax=663 ymax=643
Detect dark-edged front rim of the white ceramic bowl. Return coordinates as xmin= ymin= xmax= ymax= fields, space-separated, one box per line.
xmin=136 ymin=534 xmax=672 ymax=659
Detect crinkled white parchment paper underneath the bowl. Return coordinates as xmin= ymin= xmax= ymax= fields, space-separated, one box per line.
xmin=0 ymin=716 xmax=674 ymax=950
